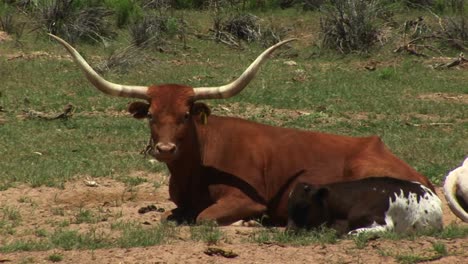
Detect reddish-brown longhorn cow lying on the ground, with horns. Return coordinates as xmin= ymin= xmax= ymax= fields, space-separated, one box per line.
xmin=51 ymin=35 xmax=432 ymax=225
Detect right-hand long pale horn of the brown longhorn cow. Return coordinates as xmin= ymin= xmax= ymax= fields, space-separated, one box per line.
xmin=194 ymin=39 xmax=297 ymax=99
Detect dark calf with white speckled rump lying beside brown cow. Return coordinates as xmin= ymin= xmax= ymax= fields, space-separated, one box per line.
xmin=287 ymin=177 xmax=442 ymax=234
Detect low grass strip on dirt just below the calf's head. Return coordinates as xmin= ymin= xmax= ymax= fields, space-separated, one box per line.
xmin=250 ymin=228 xmax=338 ymax=246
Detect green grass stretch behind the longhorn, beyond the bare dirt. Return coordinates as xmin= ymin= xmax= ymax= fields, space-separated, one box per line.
xmin=0 ymin=28 xmax=468 ymax=189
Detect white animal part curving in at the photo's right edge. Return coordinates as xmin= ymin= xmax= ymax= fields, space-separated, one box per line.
xmin=444 ymin=158 xmax=468 ymax=223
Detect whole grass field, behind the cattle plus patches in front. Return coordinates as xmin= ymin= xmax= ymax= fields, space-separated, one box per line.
xmin=0 ymin=4 xmax=468 ymax=263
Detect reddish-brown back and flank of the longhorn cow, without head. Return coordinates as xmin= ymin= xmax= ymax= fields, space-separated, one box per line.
xmin=192 ymin=116 xmax=433 ymax=224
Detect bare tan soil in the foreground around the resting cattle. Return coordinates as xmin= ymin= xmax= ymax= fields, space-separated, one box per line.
xmin=0 ymin=172 xmax=468 ymax=263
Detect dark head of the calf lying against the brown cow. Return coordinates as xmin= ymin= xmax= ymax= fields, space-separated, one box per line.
xmin=286 ymin=182 xmax=329 ymax=231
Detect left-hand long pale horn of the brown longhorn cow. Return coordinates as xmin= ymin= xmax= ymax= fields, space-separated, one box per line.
xmin=48 ymin=34 xmax=149 ymax=100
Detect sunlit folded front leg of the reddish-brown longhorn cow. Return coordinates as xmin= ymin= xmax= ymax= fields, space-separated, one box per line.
xmin=197 ymin=196 xmax=266 ymax=225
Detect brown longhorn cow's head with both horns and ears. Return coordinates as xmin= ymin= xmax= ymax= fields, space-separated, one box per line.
xmin=49 ymin=34 xmax=294 ymax=162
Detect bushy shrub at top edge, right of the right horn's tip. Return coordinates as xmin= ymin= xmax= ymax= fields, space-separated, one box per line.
xmin=320 ymin=0 xmax=388 ymax=53
